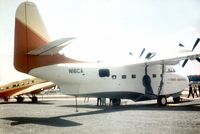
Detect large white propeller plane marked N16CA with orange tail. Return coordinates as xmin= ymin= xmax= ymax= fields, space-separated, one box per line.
xmin=14 ymin=2 xmax=200 ymax=106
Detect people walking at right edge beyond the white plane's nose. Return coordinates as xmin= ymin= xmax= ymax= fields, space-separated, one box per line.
xmin=188 ymin=84 xmax=200 ymax=98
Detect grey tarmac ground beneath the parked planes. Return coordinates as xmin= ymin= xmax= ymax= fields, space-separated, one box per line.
xmin=0 ymin=95 xmax=200 ymax=134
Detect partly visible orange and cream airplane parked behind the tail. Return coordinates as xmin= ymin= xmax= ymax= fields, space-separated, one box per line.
xmin=0 ymin=78 xmax=55 ymax=103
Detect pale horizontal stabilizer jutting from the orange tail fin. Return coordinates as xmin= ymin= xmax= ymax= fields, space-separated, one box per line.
xmin=27 ymin=37 xmax=75 ymax=55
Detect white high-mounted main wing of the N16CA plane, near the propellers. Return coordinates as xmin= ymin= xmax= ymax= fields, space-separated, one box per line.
xmin=139 ymin=52 xmax=200 ymax=67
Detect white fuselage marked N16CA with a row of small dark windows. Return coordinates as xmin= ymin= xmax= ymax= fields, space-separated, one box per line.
xmin=29 ymin=63 xmax=188 ymax=99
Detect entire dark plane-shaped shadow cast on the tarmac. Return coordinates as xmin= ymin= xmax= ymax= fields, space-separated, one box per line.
xmin=2 ymin=101 xmax=200 ymax=127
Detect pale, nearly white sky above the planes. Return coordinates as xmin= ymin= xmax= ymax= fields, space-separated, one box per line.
xmin=0 ymin=0 xmax=200 ymax=80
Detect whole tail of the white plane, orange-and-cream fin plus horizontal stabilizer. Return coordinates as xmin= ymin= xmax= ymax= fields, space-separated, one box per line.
xmin=14 ymin=2 xmax=83 ymax=73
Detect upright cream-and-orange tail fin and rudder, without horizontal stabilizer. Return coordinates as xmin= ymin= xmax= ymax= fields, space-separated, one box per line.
xmin=14 ymin=2 xmax=49 ymax=72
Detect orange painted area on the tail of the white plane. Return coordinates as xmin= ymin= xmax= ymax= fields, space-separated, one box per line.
xmin=14 ymin=18 xmax=82 ymax=73
